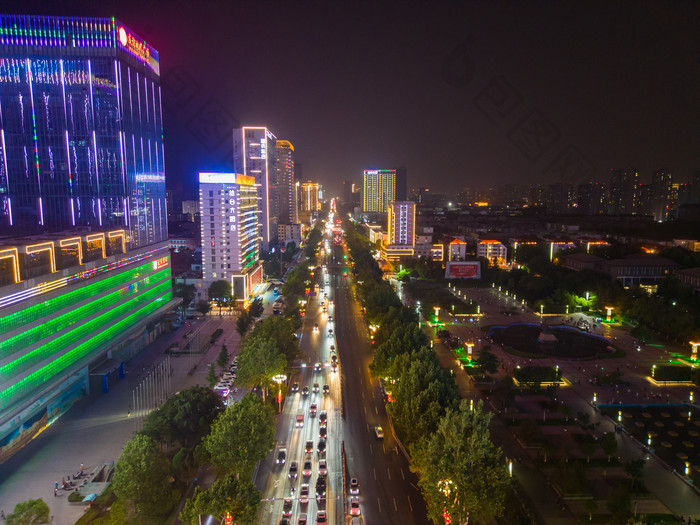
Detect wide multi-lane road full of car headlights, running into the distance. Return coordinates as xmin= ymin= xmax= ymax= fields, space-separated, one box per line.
xmin=255 ymin=227 xmax=430 ymax=525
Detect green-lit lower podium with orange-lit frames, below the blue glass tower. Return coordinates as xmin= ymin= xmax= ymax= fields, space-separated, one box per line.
xmin=0 ymin=234 xmax=177 ymax=462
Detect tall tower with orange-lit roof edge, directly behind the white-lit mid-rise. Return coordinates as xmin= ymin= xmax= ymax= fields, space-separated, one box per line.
xmin=233 ymin=126 xmax=278 ymax=250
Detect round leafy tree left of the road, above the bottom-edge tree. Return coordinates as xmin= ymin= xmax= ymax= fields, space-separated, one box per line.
xmin=204 ymin=392 xmax=275 ymax=479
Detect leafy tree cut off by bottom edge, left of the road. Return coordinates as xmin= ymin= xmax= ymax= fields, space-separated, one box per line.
xmin=180 ymin=473 xmax=262 ymax=525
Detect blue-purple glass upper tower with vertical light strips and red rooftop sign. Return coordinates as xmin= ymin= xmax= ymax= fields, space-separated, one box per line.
xmin=0 ymin=15 xmax=168 ymax=249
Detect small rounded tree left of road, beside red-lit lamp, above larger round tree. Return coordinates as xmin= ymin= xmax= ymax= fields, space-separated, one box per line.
xmin=236 ymin=331 xmax=287 ymax=401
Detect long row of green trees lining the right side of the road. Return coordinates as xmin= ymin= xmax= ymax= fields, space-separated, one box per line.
xmin=344 ymin=221 xmax=509 ymax=523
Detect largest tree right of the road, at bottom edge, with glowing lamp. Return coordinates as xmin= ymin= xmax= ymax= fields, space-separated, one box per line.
xmin=411 ymin=400 xmax=509 ymax=523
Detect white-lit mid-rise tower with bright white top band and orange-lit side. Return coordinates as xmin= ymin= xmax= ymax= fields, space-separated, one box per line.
xmin=199 ymin=173 xmax=262 ymax=301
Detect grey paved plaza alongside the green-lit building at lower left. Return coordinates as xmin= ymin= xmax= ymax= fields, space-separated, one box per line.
xmin=0 ymin=314 xmax=243 ymax=525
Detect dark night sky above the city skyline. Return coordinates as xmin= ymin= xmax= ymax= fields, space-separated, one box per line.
xmin=10 ymin=0 xmax=700 ymax=198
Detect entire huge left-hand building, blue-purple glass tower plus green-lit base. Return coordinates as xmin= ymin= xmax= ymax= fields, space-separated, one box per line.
xmin=0 ymin=15 xmax=176 ymax=461
